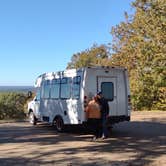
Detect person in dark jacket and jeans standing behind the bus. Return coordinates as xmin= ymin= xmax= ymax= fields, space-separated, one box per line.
xmin=97 ymin=92 xmax=109 ymax=139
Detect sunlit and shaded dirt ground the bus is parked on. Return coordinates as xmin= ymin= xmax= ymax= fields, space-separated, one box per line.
xmin=0 ymin=111 xmax=166 ymax=166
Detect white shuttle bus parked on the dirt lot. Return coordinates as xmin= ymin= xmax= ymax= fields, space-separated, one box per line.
xmin=28 ymin=67 xmax=131 ymax=131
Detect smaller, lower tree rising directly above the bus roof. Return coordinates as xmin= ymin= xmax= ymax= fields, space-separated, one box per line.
xmin=67 ymin=45 xmax=110 ymax=69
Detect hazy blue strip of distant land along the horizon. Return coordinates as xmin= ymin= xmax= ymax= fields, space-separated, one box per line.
xmin=0 ymin=86 xmax=35 ymax=92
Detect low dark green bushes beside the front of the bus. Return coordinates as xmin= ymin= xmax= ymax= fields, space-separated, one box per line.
xmin=0 ymin=92 xmax=28 ymax=120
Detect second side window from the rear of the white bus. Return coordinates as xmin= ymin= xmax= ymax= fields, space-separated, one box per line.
xmin=60 ymin=77 xmax=72 ymax=99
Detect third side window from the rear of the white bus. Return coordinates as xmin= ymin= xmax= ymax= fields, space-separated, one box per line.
xmin=51 ymin=79 xmax=60 ymax=99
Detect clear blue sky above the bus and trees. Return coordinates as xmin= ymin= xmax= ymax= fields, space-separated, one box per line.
xmin=0 ymin=0 xmax=132 ymax=86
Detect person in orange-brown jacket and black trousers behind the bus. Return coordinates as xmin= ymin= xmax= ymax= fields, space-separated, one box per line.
xmin=86 ymin=96 xmax=101 ymax=140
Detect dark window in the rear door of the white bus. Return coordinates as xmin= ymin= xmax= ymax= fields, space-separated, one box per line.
xmin=101 ymin=82 xmax=114 ymax=101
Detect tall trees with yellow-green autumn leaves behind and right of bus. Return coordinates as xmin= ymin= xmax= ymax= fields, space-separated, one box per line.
xmin=67 ymin=0 xmax=166 ymax=110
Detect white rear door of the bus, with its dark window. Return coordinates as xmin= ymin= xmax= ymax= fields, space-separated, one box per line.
xmin=97 ymin=76 xmax=118 ymax=116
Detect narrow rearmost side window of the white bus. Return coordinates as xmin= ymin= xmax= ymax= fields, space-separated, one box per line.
xmin=72 ymin=76 xmax=81 ymax=99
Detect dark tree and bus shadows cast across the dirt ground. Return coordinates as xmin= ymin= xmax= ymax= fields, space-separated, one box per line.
xmin=0 ymin=121 xmax=166 ymax=166
